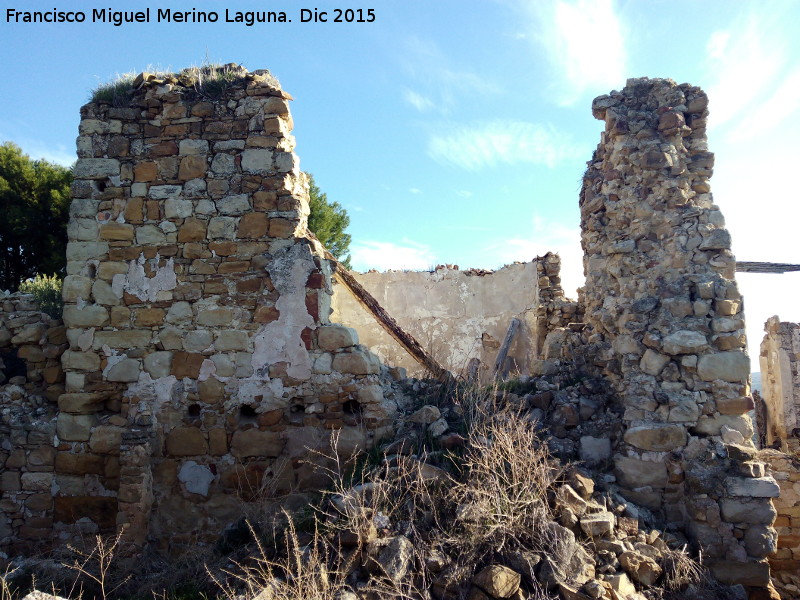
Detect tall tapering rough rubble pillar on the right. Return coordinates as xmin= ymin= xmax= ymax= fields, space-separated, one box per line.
xmin=580 ymin=78 xmax=778 ymax=586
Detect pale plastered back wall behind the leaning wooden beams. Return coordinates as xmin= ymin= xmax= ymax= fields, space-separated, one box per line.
xmin=332 ymin=261 xmax=540 ymax=379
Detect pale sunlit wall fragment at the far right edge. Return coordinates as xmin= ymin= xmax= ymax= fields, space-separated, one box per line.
xmin=759 ymin=316 xmax=800 ymax=452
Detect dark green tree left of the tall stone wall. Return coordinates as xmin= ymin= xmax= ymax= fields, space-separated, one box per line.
xmin=0 ymin=142 xmax=72 ymax=291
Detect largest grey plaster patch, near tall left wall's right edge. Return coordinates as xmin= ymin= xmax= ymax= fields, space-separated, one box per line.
xmin=252 ymin=244 xmax=316 ymax=380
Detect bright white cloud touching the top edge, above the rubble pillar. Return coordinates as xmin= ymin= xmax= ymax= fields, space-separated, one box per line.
xmin=515 ymin=0 xmax=628 ymax=105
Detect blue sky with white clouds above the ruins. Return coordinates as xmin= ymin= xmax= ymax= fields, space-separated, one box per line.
xmin=0 ymin=0 xmax=800 ymax=366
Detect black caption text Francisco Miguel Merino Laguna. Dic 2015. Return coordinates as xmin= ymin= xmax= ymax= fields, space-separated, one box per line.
xmin=6 ymin=8 xmax=375 ymax=27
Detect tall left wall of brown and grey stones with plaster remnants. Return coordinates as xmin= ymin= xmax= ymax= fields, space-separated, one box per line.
xmin=54 ymin=67 xmax=394 ymax=547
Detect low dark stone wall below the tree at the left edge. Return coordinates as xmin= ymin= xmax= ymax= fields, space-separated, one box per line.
xmin=0 ymin=294 xmax=66 ymax=565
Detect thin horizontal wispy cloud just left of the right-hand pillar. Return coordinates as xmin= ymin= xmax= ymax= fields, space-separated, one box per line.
xmin=428 ymin=120 xmax=581 ymax=171
